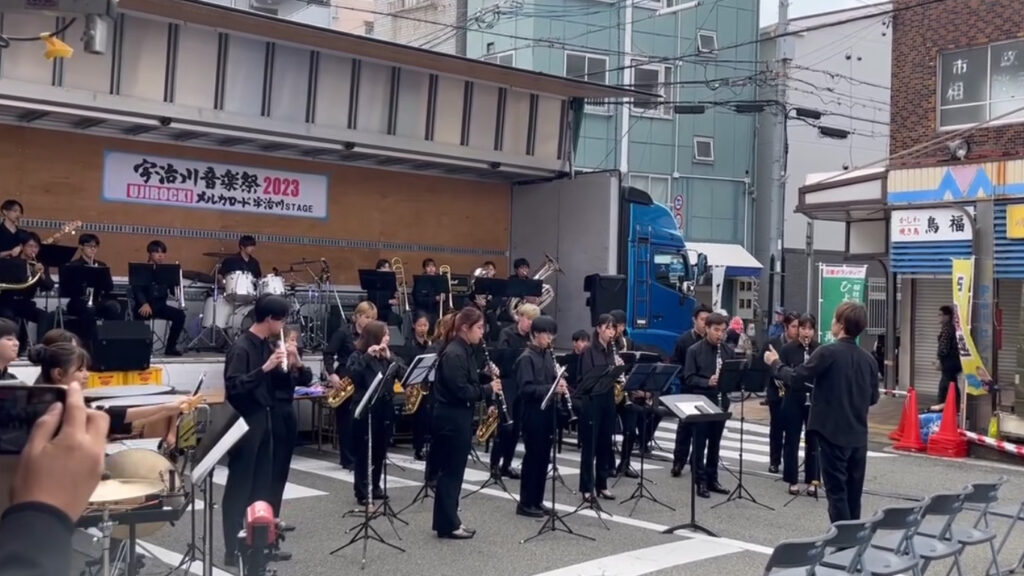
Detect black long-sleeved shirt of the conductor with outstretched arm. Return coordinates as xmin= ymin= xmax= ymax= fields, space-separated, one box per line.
xmin=771 ymin=337 xmax=879 ymax=448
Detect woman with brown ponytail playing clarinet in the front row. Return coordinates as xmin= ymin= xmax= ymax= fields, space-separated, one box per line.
xmin=430 ymin=306 xmax=502 ymax=540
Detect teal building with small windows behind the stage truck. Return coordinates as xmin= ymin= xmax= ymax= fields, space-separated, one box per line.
xmin=466 ymin=0 xmax=763 ymax=318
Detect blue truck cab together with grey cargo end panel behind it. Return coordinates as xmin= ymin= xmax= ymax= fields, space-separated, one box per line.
xmin=509 ymin=171 xmax=708 ymax=356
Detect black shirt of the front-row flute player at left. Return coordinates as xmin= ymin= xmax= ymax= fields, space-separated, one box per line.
xmin=224 ymin=330 xmax=280 ymax=417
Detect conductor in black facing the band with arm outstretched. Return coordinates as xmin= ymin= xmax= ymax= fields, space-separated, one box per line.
xmin=765 ymin=302 xmax=879 ymax=522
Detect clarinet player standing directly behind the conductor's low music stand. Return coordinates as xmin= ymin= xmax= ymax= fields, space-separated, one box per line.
xmin=683 ymin=314 xmax=732 ymax=498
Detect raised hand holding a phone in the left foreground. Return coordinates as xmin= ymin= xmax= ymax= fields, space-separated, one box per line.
xmin=11 ymin=382 xmax=111 ymax=521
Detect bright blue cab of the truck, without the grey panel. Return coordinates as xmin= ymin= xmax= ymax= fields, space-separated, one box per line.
xmin=618 ymin=187 xmax=707 ymax=356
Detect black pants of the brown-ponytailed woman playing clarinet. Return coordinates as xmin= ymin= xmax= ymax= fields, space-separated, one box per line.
xmin=430 ymin=404 xmax=473 ymax=535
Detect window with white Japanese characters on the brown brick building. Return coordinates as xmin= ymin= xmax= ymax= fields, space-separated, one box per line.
xmin=937 ymin=40 xmax=1024 ymax=128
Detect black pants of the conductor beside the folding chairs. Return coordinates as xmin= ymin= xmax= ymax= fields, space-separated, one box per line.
xmin=818 ymin=436 xmax=867 ymax=522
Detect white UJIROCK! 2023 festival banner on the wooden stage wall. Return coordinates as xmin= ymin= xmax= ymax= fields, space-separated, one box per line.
xmin=102 ymin=151 xmax=328 ymax=218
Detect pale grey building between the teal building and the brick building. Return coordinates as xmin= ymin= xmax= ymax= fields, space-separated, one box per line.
xmin=755 ymin=2 xmax=892 ymax=323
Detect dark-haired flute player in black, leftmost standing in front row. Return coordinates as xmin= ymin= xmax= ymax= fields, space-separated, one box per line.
xmin=221 ymin=294 xmax=290 ymax=566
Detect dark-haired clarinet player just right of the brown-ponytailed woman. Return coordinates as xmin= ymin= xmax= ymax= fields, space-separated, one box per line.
xmin=513 ymin=316 xmax=568 ymax=518
